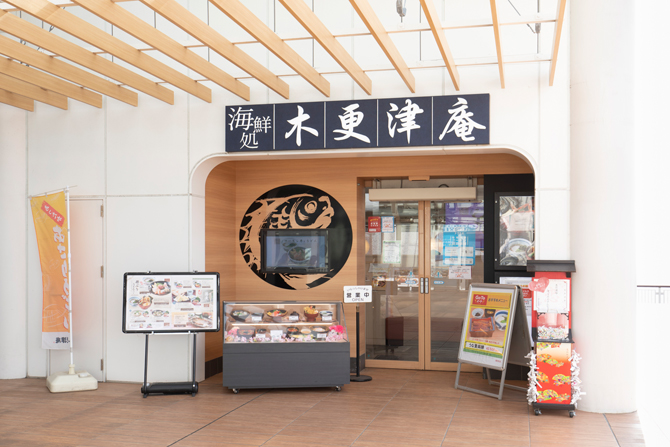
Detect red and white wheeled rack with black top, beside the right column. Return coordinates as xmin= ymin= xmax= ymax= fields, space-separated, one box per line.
xmin=527 ymin=261 xmax=581 ymax=417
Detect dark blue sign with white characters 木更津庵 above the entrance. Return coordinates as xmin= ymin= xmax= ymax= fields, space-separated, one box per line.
xmin=225 ymin=94 xmax=490 ymax=152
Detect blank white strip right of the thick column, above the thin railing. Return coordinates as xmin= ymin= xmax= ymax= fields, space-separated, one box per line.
xmin=630 ymin=1 xmax=670 ymax=286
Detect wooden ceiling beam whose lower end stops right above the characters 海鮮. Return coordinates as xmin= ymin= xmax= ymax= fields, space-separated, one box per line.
xmin=74 ymin=0 xmax=249 ymax=101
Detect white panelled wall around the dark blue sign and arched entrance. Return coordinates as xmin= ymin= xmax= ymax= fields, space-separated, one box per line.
xmin=0 ymin=0 xmax=570 ymax=382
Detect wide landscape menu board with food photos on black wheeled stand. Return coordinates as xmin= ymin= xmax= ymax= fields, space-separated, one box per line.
xmin=122 ymin=272 xmax=220 ymax=397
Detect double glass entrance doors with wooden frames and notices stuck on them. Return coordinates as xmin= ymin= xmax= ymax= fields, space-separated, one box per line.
xmin=365 ymin=196 xmax=484 ymax=370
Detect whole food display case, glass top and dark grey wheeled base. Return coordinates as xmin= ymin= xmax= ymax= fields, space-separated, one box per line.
xmin=222 ymin=301 xmax=350 ymax=393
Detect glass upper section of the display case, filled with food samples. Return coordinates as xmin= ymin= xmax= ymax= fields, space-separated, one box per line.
xmin=224 ymin=302 xmax=348 ymax=343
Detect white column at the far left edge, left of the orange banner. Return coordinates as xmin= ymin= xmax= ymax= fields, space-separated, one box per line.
xmin=0 ymin=105 xmax=29 ymax=379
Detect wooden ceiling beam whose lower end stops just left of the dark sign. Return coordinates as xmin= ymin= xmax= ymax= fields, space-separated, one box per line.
xmin=6 ymin=0 xmax=202 ymax=104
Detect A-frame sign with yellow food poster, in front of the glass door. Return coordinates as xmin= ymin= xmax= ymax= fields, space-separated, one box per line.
xmin=456 ymin=284 xmax=531 ymax=399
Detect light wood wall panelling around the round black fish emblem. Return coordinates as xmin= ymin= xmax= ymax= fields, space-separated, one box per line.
xmin=206 ymin=154 xmax=533 ymax=359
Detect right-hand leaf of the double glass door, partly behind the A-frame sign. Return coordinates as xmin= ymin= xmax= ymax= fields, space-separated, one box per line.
xmin=426 ymin=202 xmax=484 ymax=369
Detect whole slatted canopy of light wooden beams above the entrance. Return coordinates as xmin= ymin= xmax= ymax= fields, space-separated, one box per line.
xmin=0 ymin=0 xmax=567 ymax=111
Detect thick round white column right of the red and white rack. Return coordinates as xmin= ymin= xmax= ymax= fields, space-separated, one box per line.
xmin=570 ymin=0 xmax=636 ymax=413
